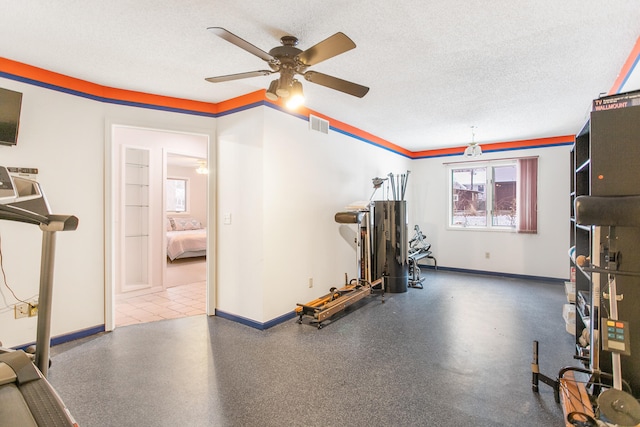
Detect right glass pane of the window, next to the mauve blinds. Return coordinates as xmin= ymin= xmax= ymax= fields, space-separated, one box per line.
xmin=491 ymin=165 xmax=517 ymax=228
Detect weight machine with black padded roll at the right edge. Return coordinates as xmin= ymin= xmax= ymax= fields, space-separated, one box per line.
xmin=531 ymin=196 xmax=640 ymax=427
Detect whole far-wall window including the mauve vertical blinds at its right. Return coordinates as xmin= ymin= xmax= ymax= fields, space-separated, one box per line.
xmin=449 ymin=157 xmax=538 ymax=233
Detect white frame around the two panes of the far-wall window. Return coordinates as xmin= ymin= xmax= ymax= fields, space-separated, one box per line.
xmin=446 ymin=158 xmax=520 ymax=233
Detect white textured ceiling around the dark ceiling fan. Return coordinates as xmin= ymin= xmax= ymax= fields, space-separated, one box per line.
xmin=0 ymin=0 xmax=640 ymax=151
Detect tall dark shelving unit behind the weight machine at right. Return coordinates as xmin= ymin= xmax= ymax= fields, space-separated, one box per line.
xmin=570 ymin=91 xmax=640 ymax=397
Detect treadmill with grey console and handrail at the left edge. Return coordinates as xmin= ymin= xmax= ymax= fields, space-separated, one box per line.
xmin=0 ymin=166 xmax=78 ymax=427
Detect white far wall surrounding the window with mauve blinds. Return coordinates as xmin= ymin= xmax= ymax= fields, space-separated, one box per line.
xmin=410 ymin=146 xmax=570 ymax=279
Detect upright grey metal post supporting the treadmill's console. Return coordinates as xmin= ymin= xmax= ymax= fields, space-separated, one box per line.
xmin=36 ymin=230 xmax=56 ymax=377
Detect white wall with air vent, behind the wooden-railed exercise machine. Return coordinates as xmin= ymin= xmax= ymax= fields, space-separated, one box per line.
xmin=263 ymin=109 xmax=411 ymax=320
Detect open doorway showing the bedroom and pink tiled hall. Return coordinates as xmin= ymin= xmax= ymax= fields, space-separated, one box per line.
xmin=106 ymin=125 xmax=210 ymax=327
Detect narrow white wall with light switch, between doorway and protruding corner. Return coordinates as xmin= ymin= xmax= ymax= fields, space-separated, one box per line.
xmin=216 ymin=108 xmax=264 ymax=320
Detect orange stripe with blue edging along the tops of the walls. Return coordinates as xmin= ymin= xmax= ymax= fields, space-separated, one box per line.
xmin=0 ymin=56 xmax=576 ymax=159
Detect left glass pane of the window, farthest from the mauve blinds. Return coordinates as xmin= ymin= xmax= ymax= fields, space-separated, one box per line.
xmin=451 ymin=167 xmax=487 ymax=227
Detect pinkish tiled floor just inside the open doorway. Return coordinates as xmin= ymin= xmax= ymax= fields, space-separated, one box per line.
xmin=116 ymin=282 xmax=206 ymax=326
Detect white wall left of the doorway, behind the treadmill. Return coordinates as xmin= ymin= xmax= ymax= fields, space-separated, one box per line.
xmin=0 ymin=79 xmax=104 ymax=346
